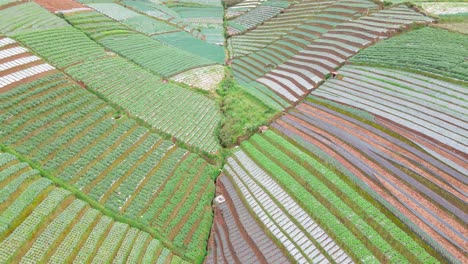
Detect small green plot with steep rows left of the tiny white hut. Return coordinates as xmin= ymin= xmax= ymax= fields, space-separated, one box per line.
xmin=141 ymin=154 xmax=216 ymax=256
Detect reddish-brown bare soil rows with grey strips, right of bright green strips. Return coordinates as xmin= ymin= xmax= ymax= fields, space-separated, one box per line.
xmin=273 ymin=104 xmax=466 ymax=259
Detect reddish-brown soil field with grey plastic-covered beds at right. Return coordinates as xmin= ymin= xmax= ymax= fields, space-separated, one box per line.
xmin=273 ymin=98 xmax=463 ymax=256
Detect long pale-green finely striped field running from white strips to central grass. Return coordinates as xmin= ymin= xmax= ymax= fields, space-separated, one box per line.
xmin=2 ymin=6 xmax=219 ymax=153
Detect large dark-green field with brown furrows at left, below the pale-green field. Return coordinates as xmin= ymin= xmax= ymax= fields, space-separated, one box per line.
xmin=1 ymin=71 xmax=215 ymax=258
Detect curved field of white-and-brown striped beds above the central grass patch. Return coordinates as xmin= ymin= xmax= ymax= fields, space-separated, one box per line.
xmin=233 ymin=3 xmax=430 ymax=104
